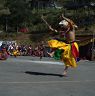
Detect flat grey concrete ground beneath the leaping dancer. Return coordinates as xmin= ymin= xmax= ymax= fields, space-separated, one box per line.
xmin=0 ymin=56 xmax=95 ymax=96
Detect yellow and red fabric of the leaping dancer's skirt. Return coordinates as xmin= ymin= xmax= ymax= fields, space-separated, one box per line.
xmin=48 ymin=40 xmax=79 ymax=68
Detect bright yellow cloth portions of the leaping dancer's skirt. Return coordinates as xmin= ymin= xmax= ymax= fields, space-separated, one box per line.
xmin=48 ymin=40 xmax=78 ymax=68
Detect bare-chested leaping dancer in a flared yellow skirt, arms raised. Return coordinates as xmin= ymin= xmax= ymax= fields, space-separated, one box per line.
xmin=42 ymin=14 xmax=79 ymax=76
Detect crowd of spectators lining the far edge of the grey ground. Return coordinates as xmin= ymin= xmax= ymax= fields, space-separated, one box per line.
xmin=0 ymin=43 xmax=50 ymax=59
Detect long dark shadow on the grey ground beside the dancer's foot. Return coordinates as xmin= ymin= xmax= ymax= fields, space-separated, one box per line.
xmin=25 ymin=71 xmax=64 ymax=77
